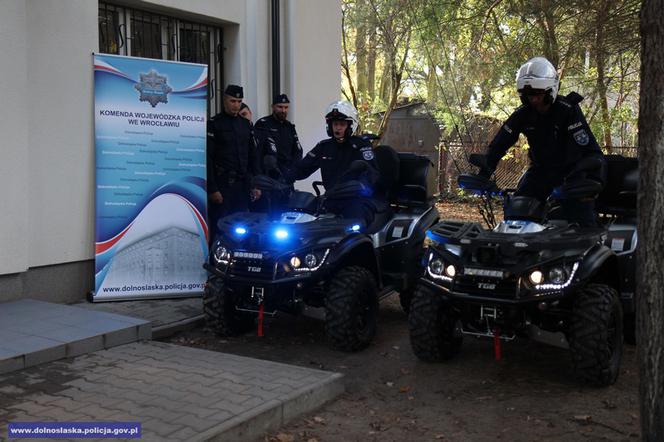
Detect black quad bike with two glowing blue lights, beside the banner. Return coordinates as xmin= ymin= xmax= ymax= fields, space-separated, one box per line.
xmin=203 ymin=146 xmax=438 ymax=351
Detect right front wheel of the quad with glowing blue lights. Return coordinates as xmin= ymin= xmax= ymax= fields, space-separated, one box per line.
xmin=325 ymin=266 xmax=378 ymax=351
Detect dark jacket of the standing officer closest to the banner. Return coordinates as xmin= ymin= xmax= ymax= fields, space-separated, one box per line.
xmin=207 ymin=112 xmax=260 ymax=193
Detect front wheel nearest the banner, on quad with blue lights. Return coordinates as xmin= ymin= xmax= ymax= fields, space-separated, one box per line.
xmin=203 ymin=277 xmax=254 ymax=336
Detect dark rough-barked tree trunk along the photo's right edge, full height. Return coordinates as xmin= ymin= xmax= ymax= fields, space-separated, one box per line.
xmin=636 ymin=0 xmax=664 ymax=442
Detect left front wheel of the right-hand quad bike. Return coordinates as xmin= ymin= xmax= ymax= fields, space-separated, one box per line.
xmin=408 ymin=284 xmax=463 ymax=362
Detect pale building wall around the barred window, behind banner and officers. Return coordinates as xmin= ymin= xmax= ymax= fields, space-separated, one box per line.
xmin=0 ymin=0 xmax=341 ymax=301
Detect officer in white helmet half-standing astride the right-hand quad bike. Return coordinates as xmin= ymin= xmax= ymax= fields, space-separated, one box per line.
xmin=480 ymin=57 xmax=603 ymax=226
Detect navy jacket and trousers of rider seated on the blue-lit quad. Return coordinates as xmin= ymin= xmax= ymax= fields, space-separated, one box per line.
xmin=285 ymin=137 xmax=385 ymax=227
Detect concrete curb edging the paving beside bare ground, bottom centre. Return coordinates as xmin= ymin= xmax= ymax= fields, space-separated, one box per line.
xmin=191 ymin=373 xmax=345 ymax=442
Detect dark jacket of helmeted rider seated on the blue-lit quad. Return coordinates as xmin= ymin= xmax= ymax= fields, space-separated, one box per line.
xmin=286 ymin=137 xmax=379 ymax=190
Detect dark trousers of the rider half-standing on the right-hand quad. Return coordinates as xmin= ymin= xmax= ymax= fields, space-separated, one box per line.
xmin=515 ymin=166 xmax=597 ymax=227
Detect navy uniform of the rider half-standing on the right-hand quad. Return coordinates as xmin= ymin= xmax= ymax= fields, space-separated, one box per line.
xmin=487 ymin=92 xmax=603 ymax=226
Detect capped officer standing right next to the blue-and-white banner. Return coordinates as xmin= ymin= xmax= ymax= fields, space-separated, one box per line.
xmin=207 ymin=84 xmax=261 ymax=239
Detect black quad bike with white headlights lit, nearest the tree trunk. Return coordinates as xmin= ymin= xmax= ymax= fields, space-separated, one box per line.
xmin=409 ymin=156 xmax=638 ymax=386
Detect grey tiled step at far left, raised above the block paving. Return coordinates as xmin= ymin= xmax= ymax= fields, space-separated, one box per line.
xmin=0 ymin=299 xmax=152 ymax=373
